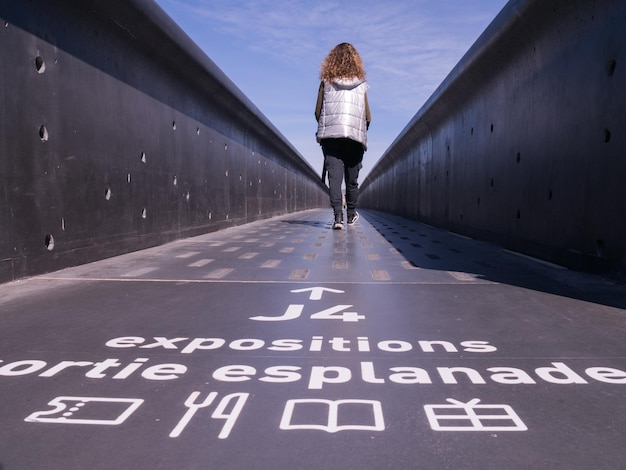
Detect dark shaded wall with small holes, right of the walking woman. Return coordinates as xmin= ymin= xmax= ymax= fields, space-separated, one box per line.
xmin=360 ymin=0 xmax=626 ymax=269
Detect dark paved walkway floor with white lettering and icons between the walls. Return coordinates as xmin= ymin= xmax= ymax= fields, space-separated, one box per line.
xmin=0 ymin=210 xmax=626 ymax=470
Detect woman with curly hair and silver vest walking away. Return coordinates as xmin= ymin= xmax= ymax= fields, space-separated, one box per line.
xmin=315 ymin=42 xmax=371 ymax=230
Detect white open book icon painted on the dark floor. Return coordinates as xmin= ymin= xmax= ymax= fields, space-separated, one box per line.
xmin=280 ymin=399 xmax=385 ymax=433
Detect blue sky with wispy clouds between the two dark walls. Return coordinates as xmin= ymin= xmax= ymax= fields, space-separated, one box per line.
xmin=157 ymin=0 xmax=507 ymax=180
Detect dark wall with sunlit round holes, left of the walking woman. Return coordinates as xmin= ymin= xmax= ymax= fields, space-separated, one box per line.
xmin=0 ymin=0 xmax=328 ymax=282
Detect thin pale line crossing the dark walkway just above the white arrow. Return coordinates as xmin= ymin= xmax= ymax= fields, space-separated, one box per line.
xmin=36 ymin=276 xmax=490 ymax=286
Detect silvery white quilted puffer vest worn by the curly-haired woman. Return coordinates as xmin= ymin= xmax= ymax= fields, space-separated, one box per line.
xmin=317 ymin=77 xmax=368 ymax=149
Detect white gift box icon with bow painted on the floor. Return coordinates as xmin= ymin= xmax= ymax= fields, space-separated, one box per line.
xmin=424 ymin=398 xmax=528 ymax=431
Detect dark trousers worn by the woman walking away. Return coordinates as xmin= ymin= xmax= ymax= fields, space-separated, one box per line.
xmin=322 ymin=139 xmax=364 ymax=217
